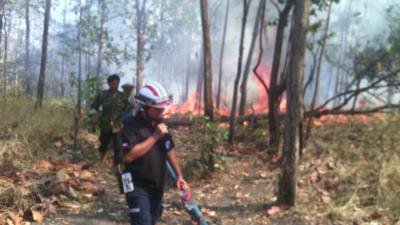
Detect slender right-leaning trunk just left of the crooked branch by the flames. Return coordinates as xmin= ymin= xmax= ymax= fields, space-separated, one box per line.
xmin=239 ymin=0 xmax=265 ymax=116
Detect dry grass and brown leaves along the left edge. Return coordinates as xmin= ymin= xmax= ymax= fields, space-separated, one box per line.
xmin=0 ymin=96 xmax=73 ymax=212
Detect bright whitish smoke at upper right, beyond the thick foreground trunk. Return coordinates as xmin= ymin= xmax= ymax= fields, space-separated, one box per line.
xmin=305 ymin=0 xmax=392 ymax=105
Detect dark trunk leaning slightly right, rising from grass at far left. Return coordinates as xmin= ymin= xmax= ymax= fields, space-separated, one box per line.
xmin=35 ymin=0 xmax=51 ymax=109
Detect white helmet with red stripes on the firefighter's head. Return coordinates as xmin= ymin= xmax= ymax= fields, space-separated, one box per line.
xmin=136 ymin=81 xmax=171 ymax=109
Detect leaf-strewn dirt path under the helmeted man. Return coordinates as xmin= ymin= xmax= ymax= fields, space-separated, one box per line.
xmin=35 ymin=144 xmax=303 ymax=225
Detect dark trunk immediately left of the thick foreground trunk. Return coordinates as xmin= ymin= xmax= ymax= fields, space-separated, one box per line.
xmin=268 ymin=1 xmax=293 ymax=154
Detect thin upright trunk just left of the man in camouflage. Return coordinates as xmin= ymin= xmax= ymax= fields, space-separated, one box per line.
xmin=73 ymin=0 xmax=82 ymax=151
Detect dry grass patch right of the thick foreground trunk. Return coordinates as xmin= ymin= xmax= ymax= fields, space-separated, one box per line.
xmin=298 ymin=115 xmax=400 ymax=224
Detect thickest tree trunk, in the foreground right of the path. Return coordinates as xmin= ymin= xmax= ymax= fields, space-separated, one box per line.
xmin=278 ymin=0 xmax=309 ymax=206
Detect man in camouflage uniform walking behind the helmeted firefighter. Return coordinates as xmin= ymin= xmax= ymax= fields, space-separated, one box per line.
xmin=89 ymin=74 xmax=129 ymax=166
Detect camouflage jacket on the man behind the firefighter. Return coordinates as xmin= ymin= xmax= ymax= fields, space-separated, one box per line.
xmin=89 ymin=90 xmax=129 ymax=133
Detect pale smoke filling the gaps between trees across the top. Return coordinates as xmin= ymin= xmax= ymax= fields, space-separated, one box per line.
xmin=25 ymin=0 xmax=394 ymax=108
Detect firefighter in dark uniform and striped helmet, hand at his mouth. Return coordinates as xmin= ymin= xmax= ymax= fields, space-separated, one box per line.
xmin=122 ymin=82 xmax=191 ymax=225
